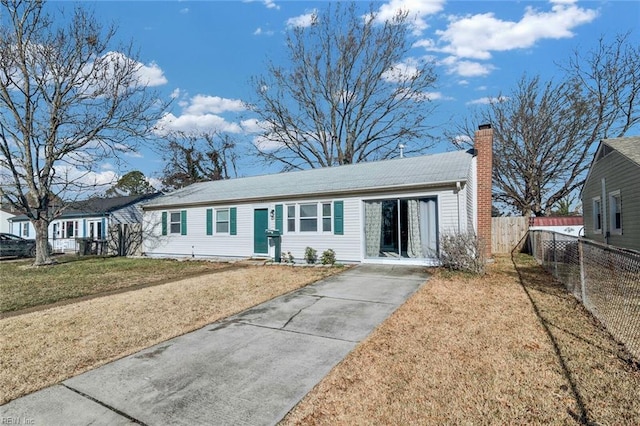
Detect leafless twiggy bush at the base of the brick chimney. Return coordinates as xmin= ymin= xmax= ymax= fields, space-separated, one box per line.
xmin=438 ymin=232 xmax=485 ymax=275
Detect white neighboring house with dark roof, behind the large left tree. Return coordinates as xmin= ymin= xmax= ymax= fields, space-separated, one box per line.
xmin=11 ymin=193 xmax=161 ymax=254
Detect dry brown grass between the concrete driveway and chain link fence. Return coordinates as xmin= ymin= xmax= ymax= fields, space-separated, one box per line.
xmin=283 ymin=258 xmax=640 ymax=425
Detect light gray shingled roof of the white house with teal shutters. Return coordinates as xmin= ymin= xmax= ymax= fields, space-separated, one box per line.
xmin=144 ymin=151 xmax=473 ymax=208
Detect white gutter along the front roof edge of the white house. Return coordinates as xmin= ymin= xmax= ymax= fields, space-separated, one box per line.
xmin=142 ymin=179 xmax=466 ymax=210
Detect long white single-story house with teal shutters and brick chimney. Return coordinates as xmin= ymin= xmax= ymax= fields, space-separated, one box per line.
xmin=143 ymin=126 xmax=493 ymax=264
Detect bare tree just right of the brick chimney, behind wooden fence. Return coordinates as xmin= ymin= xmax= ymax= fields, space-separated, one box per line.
xmin=452 ymin=76 xmax=592 ymax=216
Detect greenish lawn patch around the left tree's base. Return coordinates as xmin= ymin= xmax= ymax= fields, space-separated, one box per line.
xmin=0 ymin=256 xmax=226 ymax=312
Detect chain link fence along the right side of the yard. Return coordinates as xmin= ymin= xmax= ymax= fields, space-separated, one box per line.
xmin=529 ymin=231 xmax=640 ymax=360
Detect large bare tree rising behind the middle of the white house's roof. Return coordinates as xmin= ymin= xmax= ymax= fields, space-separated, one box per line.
xmin=252 ymin=3 xmax=436 ymax=170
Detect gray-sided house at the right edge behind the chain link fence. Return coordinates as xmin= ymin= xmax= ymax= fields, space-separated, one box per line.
xmin=581 ymin=136 xmax=640 ymax=251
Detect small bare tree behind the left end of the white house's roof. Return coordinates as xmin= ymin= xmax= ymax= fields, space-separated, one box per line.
xmin=162 ymin=132 xmax=238 ymax=189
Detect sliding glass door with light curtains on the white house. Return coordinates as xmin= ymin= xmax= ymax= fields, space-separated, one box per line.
xmin=364 ymin=198 xmax=438 ymax=258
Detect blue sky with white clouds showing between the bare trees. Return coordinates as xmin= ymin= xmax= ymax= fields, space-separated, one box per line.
xmin=52 ymin=0 xmax=640 ymax=189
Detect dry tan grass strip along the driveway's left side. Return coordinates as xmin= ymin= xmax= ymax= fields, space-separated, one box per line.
xmin=0 ymin=266 xmax=339 ymax=404
